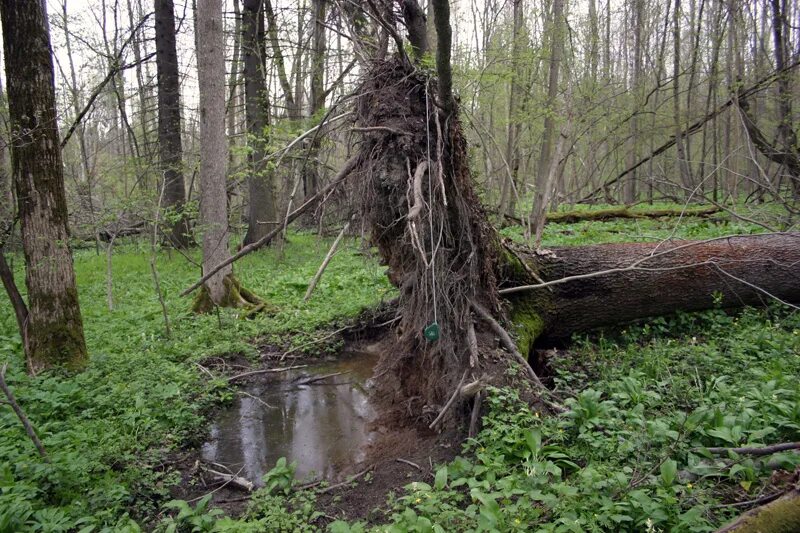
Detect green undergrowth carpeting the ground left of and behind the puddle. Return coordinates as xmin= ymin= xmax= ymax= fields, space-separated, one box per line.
xmin=0 ymin=234 xmax=393 ymax=532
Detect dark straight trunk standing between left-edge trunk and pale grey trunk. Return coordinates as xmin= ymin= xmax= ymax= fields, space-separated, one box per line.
xmin=155 ymin=0 xmax=192 ymax=248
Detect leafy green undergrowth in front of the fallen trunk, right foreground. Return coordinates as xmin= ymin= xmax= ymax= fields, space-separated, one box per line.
xmin=320 ymin=309 xmax=800 ymax=533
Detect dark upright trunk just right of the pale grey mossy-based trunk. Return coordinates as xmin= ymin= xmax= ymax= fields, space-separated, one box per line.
xmin=242 ymin=0 xmax=278 ymax=245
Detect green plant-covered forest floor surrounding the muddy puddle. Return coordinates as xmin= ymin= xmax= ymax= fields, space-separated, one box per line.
xmin=0 ymin=202 xmax=800 ymax=532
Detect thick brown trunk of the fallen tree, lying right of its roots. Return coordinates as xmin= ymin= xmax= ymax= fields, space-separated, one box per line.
xmin=500 ymin=233 xmax=800 ymax=344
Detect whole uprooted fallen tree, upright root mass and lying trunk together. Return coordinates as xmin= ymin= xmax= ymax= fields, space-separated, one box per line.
xmin=346 ymin=0 xmax=800 ymax=420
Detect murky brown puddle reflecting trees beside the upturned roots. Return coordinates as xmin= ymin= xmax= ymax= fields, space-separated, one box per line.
xmin=203 ymin=353 xmax=377 ymax=485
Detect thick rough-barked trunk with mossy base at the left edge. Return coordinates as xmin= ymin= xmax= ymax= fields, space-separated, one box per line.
xmin=0 ymin=0 xmax=88 ymax=373
